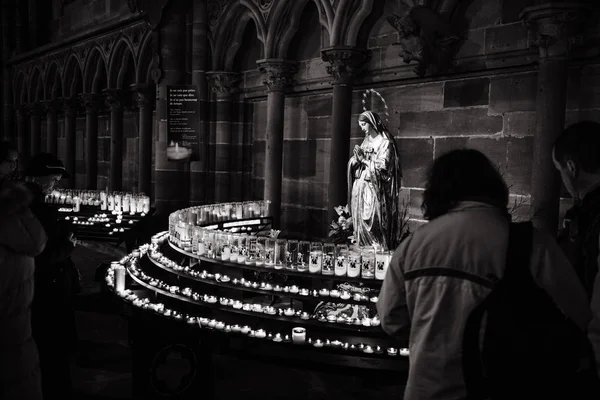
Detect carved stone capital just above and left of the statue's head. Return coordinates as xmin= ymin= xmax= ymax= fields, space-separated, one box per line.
xmin=321 ymin=46 xmax=369 ymax=85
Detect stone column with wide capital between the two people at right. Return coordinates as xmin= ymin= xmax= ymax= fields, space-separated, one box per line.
xmin=521 ymin=3 xmax=584 ymax=235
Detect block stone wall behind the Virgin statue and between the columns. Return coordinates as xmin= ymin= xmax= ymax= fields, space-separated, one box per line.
xmin=245 ymin=0 xmax=600 ymax=236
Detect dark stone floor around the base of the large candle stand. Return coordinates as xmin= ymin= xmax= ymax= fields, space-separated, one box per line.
xmin=73 ymin=242 xmax=403 ymax=400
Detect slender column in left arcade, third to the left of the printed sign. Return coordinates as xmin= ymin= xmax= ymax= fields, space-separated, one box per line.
xmin=81 ymin=93 xmax=100 ymax=190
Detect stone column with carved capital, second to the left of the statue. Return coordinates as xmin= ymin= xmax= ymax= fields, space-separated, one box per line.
xmin=257 ymin=59 xmax=298 ymax=229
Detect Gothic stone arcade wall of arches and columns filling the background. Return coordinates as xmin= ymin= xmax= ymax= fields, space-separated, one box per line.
xmin=2 ymin=0 xmax=600 ymax=236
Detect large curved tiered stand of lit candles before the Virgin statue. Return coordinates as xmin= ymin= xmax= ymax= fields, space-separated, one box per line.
xmin=106 ymin=202 xmax=408 ymax=398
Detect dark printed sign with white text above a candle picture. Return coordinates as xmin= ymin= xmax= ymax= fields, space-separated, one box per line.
xmin=167 ymin=85 xmax=200 ymax=161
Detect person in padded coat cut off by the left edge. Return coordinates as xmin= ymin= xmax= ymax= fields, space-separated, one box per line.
xmin=0 ymin=143 xmax=46 ymax=400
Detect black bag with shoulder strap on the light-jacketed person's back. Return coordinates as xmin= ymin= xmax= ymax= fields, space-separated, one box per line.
xmin=463 ymin=222 xmax=600 ymax=400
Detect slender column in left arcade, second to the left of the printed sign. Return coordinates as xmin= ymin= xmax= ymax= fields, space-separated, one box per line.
xmin=102 ymin=89 xmax=123 ymax=191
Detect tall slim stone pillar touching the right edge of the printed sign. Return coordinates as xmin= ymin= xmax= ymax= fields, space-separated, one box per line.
xmin=190 ymin=1 xmax=211 ymax=204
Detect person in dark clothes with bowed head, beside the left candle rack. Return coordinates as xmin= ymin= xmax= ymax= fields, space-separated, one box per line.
xmin=25 ymin=153 xmax=78 ymax=399
